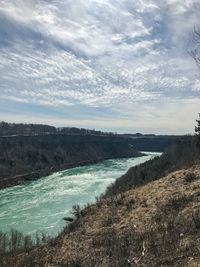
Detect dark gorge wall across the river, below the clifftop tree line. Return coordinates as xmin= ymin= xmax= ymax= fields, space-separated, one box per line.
xmin=0 ymin=134 xmax=142 ymax=188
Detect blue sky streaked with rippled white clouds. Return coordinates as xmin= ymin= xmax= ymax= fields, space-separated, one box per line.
xmin=0 ymin=0 xmax=200 ymax=134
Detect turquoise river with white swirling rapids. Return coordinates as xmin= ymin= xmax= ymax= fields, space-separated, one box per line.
xmin=0 ymin=152 xmax=160 ymax=236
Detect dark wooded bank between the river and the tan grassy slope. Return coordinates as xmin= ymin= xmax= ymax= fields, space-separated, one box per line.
xmin=105 ymin=136 xmax=200 ymax=197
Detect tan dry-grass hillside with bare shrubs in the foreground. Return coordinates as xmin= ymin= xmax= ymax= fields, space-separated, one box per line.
xmin=1 ymin=165 xmax=200 ymax=267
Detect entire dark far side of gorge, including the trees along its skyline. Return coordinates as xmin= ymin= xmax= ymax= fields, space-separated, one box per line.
xmin=0 ymin=122 xmax=176 ymax=188
